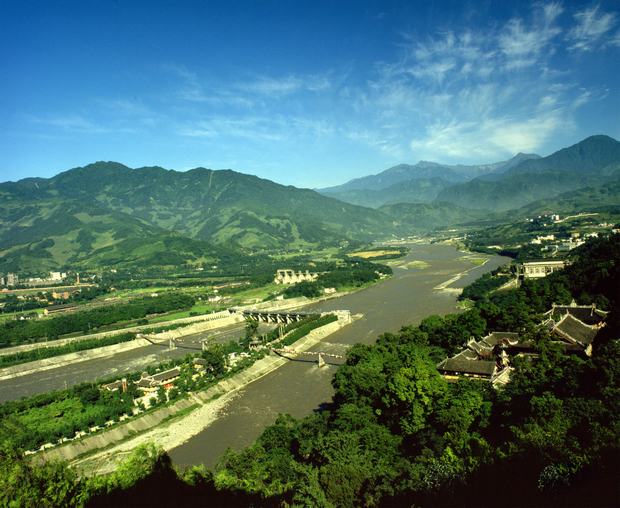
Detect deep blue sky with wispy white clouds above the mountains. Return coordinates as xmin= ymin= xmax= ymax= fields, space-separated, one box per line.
xmin=0 ymin=0 xmax=620 ymax=187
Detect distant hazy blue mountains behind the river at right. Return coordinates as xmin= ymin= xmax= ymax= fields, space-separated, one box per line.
xmin=319 ymin=135 xmax=620 ymax=212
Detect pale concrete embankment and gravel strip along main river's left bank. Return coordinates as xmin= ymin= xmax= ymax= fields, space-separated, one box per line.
xmin=36 ymin=320 xmax=349 ymax=472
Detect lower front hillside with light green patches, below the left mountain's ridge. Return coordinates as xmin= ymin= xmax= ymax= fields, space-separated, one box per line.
xmin=0 ymin=199 xmax=231 ymax=273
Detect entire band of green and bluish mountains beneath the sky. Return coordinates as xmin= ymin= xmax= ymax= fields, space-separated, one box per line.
xmin=0 ymin=136 xmax=620 ymax=272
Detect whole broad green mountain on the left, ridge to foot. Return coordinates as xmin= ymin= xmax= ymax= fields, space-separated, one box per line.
xmin=0 ymin=162 xmax=393 ymax=271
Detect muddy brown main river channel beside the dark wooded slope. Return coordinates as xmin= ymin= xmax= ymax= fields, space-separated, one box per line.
xmin=170 ymin=244 xmax=509 ymax=467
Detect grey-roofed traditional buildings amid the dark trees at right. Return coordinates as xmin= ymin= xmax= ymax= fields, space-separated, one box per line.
xmin=437 ymin=302 xmax=607 ymax=387
